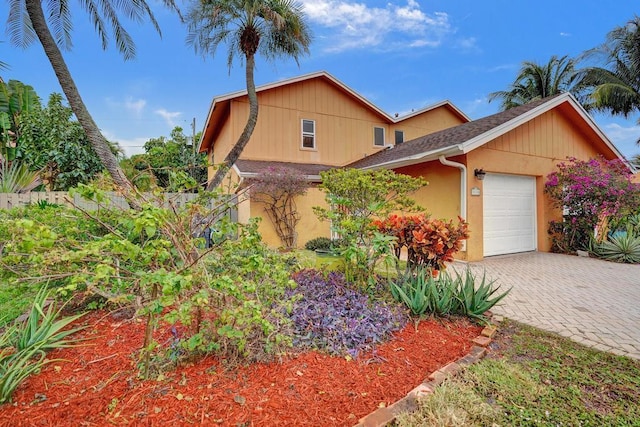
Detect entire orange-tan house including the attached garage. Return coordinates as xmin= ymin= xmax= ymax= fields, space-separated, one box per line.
xmin=200 ymin=72 xmax=626 ymax=261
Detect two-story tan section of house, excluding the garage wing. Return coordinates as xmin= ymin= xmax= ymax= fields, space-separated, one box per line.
xmin=200 ymin=72 xmax=470 ymax=246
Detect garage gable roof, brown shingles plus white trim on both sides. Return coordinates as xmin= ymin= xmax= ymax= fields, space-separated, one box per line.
xmin=347 ymin=93 xmax=629 ymax=169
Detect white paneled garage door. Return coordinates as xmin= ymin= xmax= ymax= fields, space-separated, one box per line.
xmin=482 ymin=174 xmax=536 ymax=256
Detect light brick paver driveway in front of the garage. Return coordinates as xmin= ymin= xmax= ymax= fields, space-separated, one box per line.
xmin=454 ymin=252 xmax=640 ymax=359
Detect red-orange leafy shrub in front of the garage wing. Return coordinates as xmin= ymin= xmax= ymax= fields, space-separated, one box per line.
xmin=373 ymin=214 xmax=469 ymax=271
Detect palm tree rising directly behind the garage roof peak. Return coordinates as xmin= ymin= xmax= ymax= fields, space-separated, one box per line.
xmin=489 ymin=55 xmax=579 ymax=111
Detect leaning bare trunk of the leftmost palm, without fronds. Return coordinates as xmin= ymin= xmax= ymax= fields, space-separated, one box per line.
xmin=25 ymin=0 xmax=137 ymax=204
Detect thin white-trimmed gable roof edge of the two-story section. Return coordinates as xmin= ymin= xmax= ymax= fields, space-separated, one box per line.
xmin=199 ymin=71 xmax=471 ymax=152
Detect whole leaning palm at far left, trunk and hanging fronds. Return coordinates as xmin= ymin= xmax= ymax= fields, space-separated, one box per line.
xmin=7 ymin=0 xmax=177 ymax=196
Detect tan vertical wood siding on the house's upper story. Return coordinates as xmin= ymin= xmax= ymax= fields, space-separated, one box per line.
xmin=213 ymin=78 xmax=463 ymax=166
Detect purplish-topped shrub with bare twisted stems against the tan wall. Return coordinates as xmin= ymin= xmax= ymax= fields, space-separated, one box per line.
xmin=249 ymin=166 xmax=308 ymax=249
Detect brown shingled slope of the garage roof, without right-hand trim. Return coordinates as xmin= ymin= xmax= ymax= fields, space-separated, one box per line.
xmin=347 ymin=95 xmax=560 ymax=168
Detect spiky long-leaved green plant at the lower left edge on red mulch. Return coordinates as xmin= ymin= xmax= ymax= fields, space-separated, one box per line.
xmin=0 ymin=287 xmax=83 ymax=403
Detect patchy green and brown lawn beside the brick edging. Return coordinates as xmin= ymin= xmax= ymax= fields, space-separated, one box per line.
xmin=396 ymin=321 xmax=640 ymax=427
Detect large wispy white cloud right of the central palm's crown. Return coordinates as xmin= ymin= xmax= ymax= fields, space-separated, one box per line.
xmin=302 ymin=0 xmax=452 ymax=52
